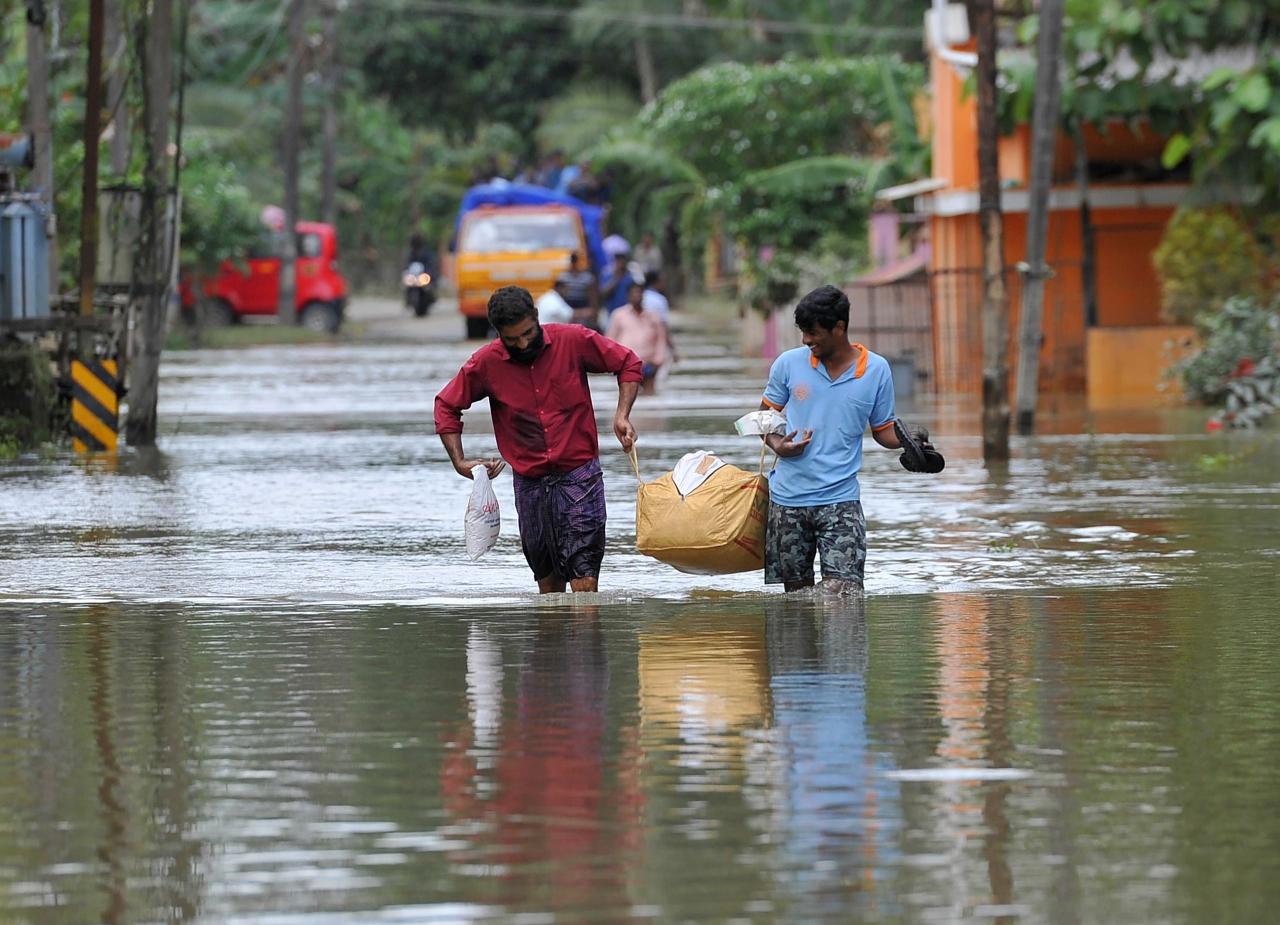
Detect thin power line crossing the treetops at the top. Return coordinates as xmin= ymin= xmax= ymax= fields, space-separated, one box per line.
xmin=389 ymin=0 xmax=924 ymax=41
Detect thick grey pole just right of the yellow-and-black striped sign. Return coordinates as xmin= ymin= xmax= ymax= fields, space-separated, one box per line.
xmin=123 ymin=0 xmax=177 ymax=447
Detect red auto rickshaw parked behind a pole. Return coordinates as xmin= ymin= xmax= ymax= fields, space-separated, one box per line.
xmin=182 ymin=221 xmax=347 ymax=334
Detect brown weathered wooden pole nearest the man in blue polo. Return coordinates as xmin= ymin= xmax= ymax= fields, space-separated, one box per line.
xmin=970 ymin=0 xmax=1009 ymax=466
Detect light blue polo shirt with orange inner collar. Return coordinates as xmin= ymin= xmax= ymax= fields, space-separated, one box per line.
xmin=764 ymin=344 xmax=893 ymax=508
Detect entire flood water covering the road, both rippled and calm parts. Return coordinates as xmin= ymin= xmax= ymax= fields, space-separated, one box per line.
xmin=0 ymin=314 xmax=1280 ymax=925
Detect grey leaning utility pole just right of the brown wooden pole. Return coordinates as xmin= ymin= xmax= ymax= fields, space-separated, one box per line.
xmin=1014 ymin=0 xmax=1062 ymax=435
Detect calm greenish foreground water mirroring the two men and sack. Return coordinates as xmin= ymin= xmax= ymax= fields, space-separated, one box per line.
xmin=0 ymin=581 xmax=1280 ymax=924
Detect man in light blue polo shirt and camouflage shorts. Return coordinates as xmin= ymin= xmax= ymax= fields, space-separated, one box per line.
xmin=760 ymin=285 xmax=901 ymax=591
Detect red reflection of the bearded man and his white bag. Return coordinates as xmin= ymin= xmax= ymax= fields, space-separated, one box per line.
xmin=440 ymin=605 xmax=639 ymax=908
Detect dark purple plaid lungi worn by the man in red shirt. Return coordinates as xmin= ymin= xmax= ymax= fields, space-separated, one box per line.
xmin=512 ymin=459 xmax=605 ymax=581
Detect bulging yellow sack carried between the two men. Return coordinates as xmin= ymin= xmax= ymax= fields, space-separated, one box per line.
xmin=632 ymin=458 xmax=769 ymax=574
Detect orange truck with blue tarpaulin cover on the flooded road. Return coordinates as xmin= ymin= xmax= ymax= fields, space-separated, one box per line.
xmin=453 ymin=183 xmax=603 ymax=338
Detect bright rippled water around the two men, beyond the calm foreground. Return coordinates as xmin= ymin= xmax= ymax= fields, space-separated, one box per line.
xmin=0 ymin=292 xmax=1270 ymax=603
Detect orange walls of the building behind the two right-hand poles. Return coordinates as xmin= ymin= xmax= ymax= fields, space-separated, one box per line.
xmin=929 ymin=45 xmax=1174 ymax=394
